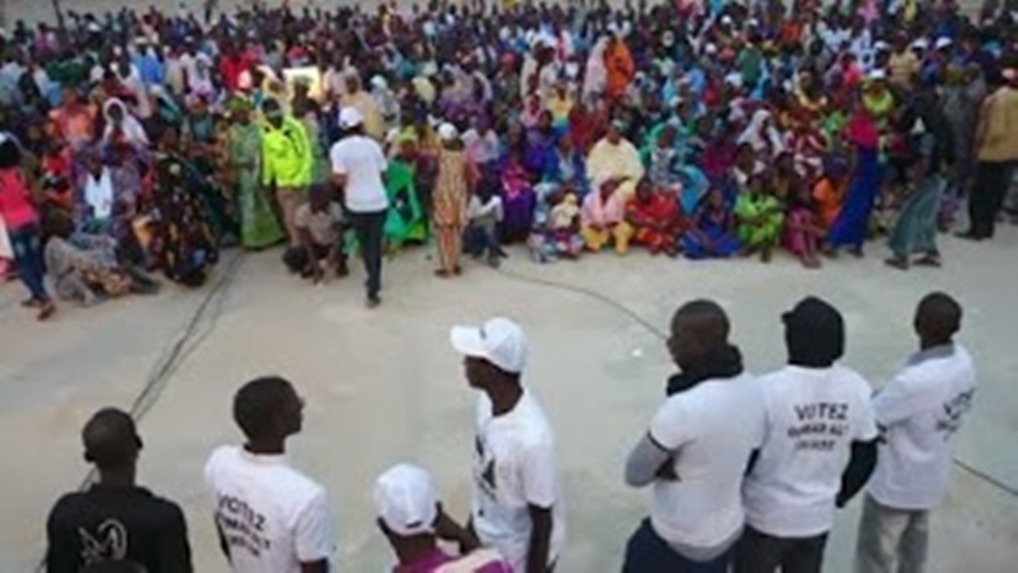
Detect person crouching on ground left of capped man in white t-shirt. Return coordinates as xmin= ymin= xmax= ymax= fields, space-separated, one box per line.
xmin=283 ymin=184 xmax=349 ymax=284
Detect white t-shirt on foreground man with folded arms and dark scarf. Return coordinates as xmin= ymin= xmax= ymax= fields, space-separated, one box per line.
xmin=651 ymin=374 xmax=764 ymax=549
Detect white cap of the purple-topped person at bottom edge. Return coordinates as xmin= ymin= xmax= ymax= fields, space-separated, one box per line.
xmin=375 ymin=463 xmax=439 ymax=537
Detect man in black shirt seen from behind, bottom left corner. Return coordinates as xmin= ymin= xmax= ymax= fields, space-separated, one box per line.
xmin=46 ymin=408 xmax=191 ymax=573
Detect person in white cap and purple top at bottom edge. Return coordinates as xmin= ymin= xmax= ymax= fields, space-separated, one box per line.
xmin=375 ymin=463 xmax=511 ymax=573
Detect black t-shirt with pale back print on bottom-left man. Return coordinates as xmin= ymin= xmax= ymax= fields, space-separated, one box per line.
xmin=46 ymin=484 xmax=191 ymax=573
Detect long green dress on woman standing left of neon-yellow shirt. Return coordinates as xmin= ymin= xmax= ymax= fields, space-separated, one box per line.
xmin=229 ymin=122 xmax=285 ymax=248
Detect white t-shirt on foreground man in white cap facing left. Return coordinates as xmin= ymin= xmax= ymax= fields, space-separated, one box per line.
xmin=471 ymin=391 xmax=566 ymax=571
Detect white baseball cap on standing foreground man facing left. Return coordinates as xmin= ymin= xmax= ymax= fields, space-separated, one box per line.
xmin=449 ymin=318 xmax=527 ymax=374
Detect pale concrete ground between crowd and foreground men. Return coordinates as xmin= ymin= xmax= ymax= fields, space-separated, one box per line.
xmin=0 ymin=227 xmax=1018 ymax=573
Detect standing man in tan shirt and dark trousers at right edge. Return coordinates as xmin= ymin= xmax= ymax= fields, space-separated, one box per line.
xmin=958 ymin=67 xmax=1018 ymax=241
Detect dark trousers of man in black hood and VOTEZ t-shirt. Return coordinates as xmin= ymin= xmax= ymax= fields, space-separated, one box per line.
xmin=735 ymin=526 xmax=828 ymax=573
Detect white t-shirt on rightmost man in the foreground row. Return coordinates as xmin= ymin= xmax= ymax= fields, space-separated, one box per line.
xmin=867 ymin=344 xmax=975 ymax=510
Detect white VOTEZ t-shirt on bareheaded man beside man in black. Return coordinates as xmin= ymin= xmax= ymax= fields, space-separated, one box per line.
xmin=205 ymin=446 xmax=335 ymax=573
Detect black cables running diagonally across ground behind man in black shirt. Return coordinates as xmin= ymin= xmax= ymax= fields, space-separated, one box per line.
xmin=36 ymin=251 xmax=246 ymax=573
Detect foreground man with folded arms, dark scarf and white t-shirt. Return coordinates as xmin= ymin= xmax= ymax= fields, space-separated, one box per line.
xmin=623 ymin=300 xmax=764 ymax=573
